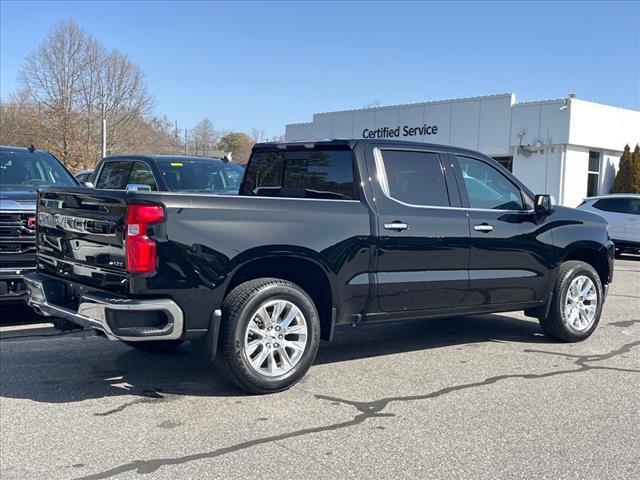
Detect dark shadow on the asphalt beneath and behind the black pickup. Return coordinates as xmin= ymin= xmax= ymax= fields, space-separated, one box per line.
xmin=0 ymin=315 xmax=550 ymax=404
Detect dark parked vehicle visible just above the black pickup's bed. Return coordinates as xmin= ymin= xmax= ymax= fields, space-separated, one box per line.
xmin=92 ymin=155 xmax=244 ymax=195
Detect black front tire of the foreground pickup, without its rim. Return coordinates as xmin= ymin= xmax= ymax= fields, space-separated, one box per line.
xmin=540 ymin=260 xmax=604 ymax=342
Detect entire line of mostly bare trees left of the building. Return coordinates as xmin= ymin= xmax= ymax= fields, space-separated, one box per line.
xmin=5 ymin=21 xmax=265 ymax=170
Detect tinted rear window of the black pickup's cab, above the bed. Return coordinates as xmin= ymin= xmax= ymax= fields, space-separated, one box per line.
xmin=243 ymin=150 xmax=358 ymax=200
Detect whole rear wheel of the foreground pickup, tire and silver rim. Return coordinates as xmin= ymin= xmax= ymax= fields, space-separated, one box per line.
xmin=216 ymin=278 xmax=320 ymax=393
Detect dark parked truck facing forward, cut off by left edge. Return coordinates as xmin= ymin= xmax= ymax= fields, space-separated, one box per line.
xmin=0 ymin=146 xmax=77 ymax=303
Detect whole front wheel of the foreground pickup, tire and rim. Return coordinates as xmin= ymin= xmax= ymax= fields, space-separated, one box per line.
xmin=540 ymin=260 xmax=604 ymax=342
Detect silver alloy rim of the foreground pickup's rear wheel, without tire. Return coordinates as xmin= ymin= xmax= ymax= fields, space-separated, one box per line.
xmin=244 ymin=300 xmax=307 ymax=377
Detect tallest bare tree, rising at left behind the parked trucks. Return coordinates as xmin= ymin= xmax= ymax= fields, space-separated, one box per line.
xmin=14 ymin=22 xmax=154 ymax=168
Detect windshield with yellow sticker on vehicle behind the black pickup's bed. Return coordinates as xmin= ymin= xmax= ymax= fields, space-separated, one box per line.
xmin=158 ymin=158 xmax=244 ymax=194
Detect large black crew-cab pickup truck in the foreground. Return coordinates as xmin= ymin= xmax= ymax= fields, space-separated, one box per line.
xmin=28 ymin=140 xmax=614 ymax=393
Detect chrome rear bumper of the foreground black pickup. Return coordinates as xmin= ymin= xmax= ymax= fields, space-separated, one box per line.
xmin=24 ymin=273 xmax=184 ymax=342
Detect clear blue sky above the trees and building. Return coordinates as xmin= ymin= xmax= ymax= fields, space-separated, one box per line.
xmin=0 ymin=1 xmax=640 ymax=135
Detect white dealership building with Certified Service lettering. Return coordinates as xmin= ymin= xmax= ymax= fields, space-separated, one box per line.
xmin=285 ymin=93 xmax=640 ymax=206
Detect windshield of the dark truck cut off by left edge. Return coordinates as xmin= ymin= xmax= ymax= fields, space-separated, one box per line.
xmin=0 ymin=151 xmax=77 ymax=190
